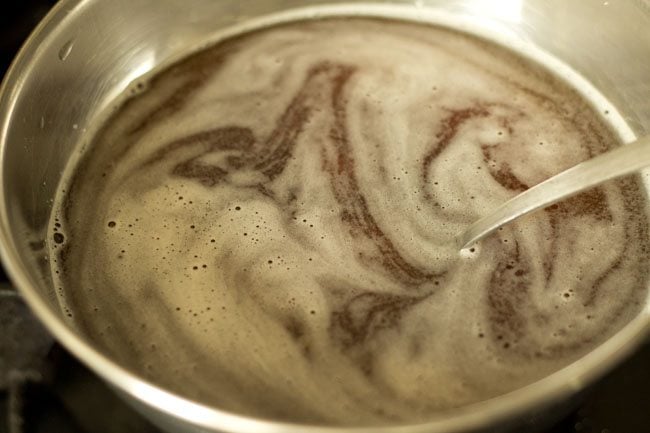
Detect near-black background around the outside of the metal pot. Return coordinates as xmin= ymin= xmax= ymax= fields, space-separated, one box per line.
xmin=0 ymin=0 xmax=650 ymax=433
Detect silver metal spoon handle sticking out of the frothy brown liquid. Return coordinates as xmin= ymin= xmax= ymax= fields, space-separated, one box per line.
xmin=456 ymin=136 xmax=650 ymax=250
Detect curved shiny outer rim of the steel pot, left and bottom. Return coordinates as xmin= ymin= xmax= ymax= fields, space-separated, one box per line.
xmin=0 ymin=0 xmax=650 ymax=433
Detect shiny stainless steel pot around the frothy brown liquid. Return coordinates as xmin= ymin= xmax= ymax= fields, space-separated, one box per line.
xmin=0 ymin=0 xmax=650 ymax=433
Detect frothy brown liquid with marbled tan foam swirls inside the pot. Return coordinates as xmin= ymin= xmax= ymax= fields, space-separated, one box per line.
xmin=50 ymin=18 xmax=648 ymax=425
